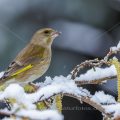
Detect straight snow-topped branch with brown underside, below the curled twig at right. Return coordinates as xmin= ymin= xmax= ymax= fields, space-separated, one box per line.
xmin=75 ymin=65 xmax=117 ymax=85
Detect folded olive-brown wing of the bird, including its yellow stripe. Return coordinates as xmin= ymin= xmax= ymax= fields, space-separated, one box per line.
xmin=3 ymin=45 xmax=43 ymax=78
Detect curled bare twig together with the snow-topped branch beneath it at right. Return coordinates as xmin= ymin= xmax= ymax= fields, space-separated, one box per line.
xmin=71 ymin=42 xmax=120 ymax=85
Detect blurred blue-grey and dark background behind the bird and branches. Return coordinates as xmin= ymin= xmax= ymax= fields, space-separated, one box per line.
xmin=0 ymin=0 xmax=120 ymax=120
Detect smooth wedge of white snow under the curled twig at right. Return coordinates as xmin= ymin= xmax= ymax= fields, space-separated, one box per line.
xmin=75 ymin=65 xmax=117 ymax=81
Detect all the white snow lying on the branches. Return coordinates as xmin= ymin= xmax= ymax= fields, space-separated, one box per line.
xmin=0 ymin=42 xmax=120 ymax=120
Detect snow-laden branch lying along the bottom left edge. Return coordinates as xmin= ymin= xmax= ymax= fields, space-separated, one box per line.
xmin=0 ymin=110 xmax=63 ymax=120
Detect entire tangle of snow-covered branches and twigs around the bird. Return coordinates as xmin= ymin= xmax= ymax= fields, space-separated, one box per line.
xmin=0 ymin=43 xmax=120 ymax=120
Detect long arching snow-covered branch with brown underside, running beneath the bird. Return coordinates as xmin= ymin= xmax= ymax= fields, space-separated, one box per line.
xmin=0 ymin=76 xmax=120 ymax=119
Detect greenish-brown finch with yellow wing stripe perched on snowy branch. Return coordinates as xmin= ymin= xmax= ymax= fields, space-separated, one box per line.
xmin=0 ymin=28 xmax=60 ymax=86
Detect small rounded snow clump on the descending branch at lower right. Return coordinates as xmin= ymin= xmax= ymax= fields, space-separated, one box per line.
xmin=91 ymin=91 xmax=116 ymax=104
